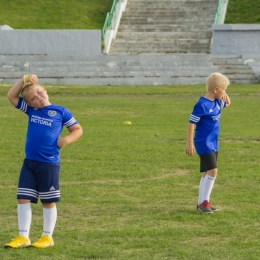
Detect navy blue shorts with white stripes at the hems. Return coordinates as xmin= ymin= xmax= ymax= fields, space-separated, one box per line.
xmin=17 ymin=159 xmax=60 ymax=203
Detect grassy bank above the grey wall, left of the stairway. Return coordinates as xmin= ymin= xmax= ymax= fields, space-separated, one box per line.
xmin=0 ymin=0 xmax=113 ymax=29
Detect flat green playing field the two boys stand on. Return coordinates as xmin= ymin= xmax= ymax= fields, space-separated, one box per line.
xmin=0 ymin=84 xmax=260 ymax=260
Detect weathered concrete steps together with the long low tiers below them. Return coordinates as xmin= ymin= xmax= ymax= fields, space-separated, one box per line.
xmin=0 ymin=0 xmax=260 ymax=85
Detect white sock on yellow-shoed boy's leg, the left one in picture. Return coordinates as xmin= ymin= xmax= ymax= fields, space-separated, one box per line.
xmin=17 ymin=203 xmax=32 ymax=238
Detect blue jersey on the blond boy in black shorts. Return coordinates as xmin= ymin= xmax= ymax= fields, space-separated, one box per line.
xmin=189 ymin=97 xmax=226 ymax=154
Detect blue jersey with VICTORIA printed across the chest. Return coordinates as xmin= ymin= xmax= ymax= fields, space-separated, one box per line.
xmin=16 ymin=97 xmax=77 ymax=162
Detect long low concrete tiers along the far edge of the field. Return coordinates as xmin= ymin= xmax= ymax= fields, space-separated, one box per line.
xmin=0 ymin=54 xmax=257 ymax=86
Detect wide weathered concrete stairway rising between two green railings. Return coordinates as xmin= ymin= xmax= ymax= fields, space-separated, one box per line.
xmin=110 ymin=0 xmax=218 ymax=54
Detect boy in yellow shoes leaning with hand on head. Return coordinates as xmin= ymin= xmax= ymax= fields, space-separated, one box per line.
xmin=5 ymin=74 xmax=83 ymax=248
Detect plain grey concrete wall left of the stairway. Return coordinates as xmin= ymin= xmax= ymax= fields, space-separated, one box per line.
xmin=0 ymin=30 xmax=102 ymax=55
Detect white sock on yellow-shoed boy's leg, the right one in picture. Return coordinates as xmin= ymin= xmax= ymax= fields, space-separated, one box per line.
xmin=42 ymin=205 xmax=57 ymax=238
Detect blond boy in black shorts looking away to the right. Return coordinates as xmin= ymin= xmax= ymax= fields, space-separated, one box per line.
xmin=186 ymin=73 xmax=231 ymax=213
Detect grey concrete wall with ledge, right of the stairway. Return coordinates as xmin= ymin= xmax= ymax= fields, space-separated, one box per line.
xmin=211 ymin=24 xmax=260 ymax=55
